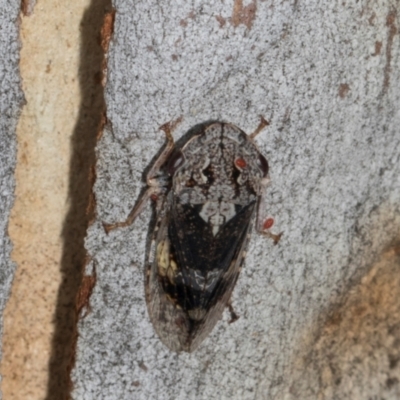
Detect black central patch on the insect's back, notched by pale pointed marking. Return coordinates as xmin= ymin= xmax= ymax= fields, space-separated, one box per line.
xmin=164 ymin=201 xmax=255 ymax=310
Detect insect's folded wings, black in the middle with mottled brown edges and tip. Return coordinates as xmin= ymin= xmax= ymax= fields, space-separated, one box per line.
xmin=146 ymin=192 xmax=255 ymax=352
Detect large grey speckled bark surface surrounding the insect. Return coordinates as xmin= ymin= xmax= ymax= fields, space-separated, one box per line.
xmin=72 ymin=0 xmax=400 ymax=400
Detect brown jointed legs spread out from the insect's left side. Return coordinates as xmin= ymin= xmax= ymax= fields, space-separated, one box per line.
xmin=103 ymin=120 xmax=179 ymax=233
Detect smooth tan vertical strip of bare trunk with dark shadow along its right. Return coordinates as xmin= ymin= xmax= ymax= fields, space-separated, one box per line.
xmin=1 ymin=0 xmax=108 ymax=400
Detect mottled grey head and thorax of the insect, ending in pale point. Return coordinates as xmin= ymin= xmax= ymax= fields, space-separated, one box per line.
xmin=173 ymin=123 xmax=263 ymax=236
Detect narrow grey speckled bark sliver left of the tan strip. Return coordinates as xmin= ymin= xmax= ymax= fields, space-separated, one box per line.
xmin=0 ymin=1 xmax=23 ymax=397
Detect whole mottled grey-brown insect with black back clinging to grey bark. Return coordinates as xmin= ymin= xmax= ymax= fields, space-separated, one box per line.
xmin=104 ymin=118 xmax=282 ymax=352
